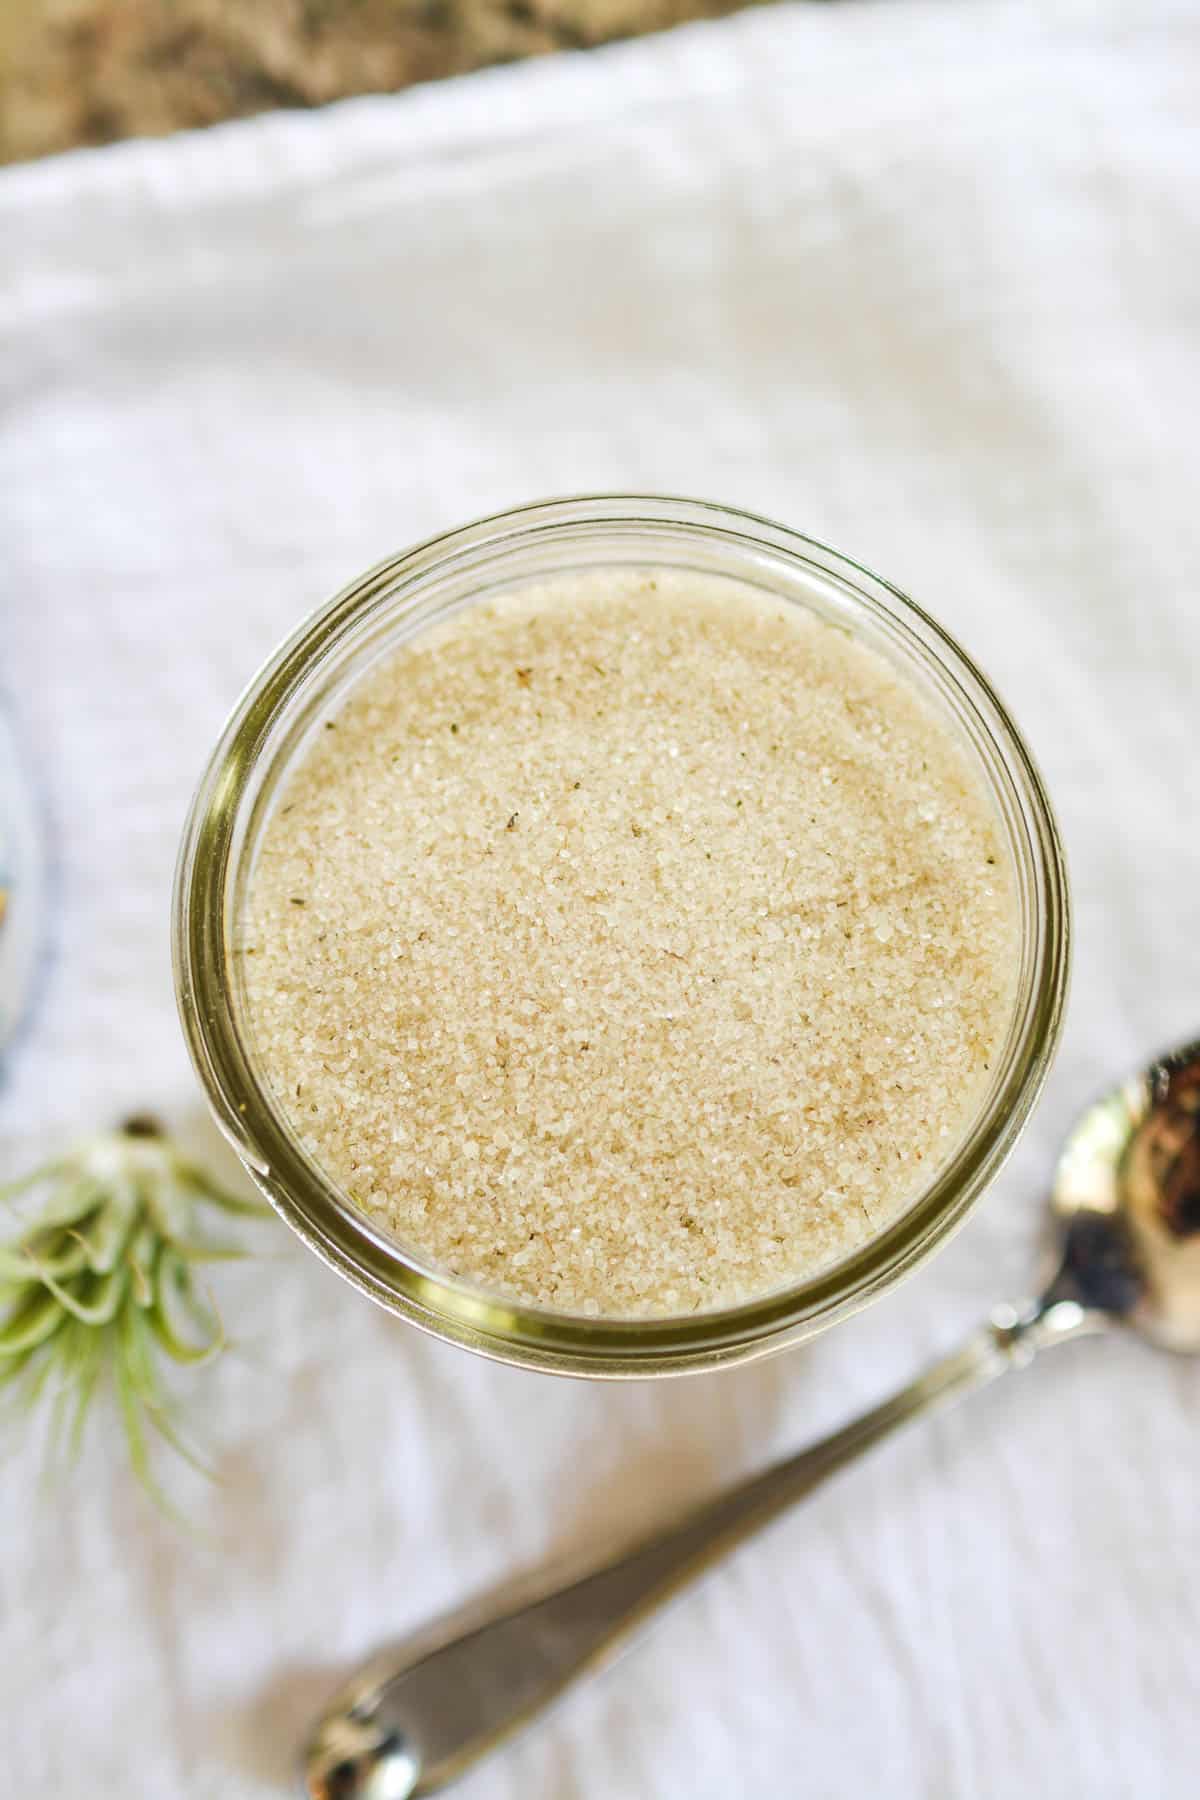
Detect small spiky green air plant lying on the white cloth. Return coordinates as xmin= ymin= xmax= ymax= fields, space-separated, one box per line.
xmin=0 ymin=1118 xmax=266 ymax=1499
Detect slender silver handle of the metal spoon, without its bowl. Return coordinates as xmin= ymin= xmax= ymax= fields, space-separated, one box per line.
xmin=308 ymin=1301 xmax=1096 ymax=1800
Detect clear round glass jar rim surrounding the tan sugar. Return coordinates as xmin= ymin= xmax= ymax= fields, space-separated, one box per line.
xmin=173 ymin=497 xmax=1069 ymax=1375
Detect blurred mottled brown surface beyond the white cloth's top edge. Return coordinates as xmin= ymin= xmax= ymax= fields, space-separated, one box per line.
xmin=0 ymin=0 xmax=766 ymax=162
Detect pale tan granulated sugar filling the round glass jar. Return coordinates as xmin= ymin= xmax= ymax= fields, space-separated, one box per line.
xmin=245 ymin=571 xmax=1018 ymax=1316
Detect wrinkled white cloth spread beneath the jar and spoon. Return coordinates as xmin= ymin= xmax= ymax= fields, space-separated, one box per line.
xmin=0 ymin=0 xmax=1200 ymax=1800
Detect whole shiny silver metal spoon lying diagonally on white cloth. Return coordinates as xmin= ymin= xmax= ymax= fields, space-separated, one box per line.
xmin=304 ymin=1042 xmax=1200 ymax=1800
